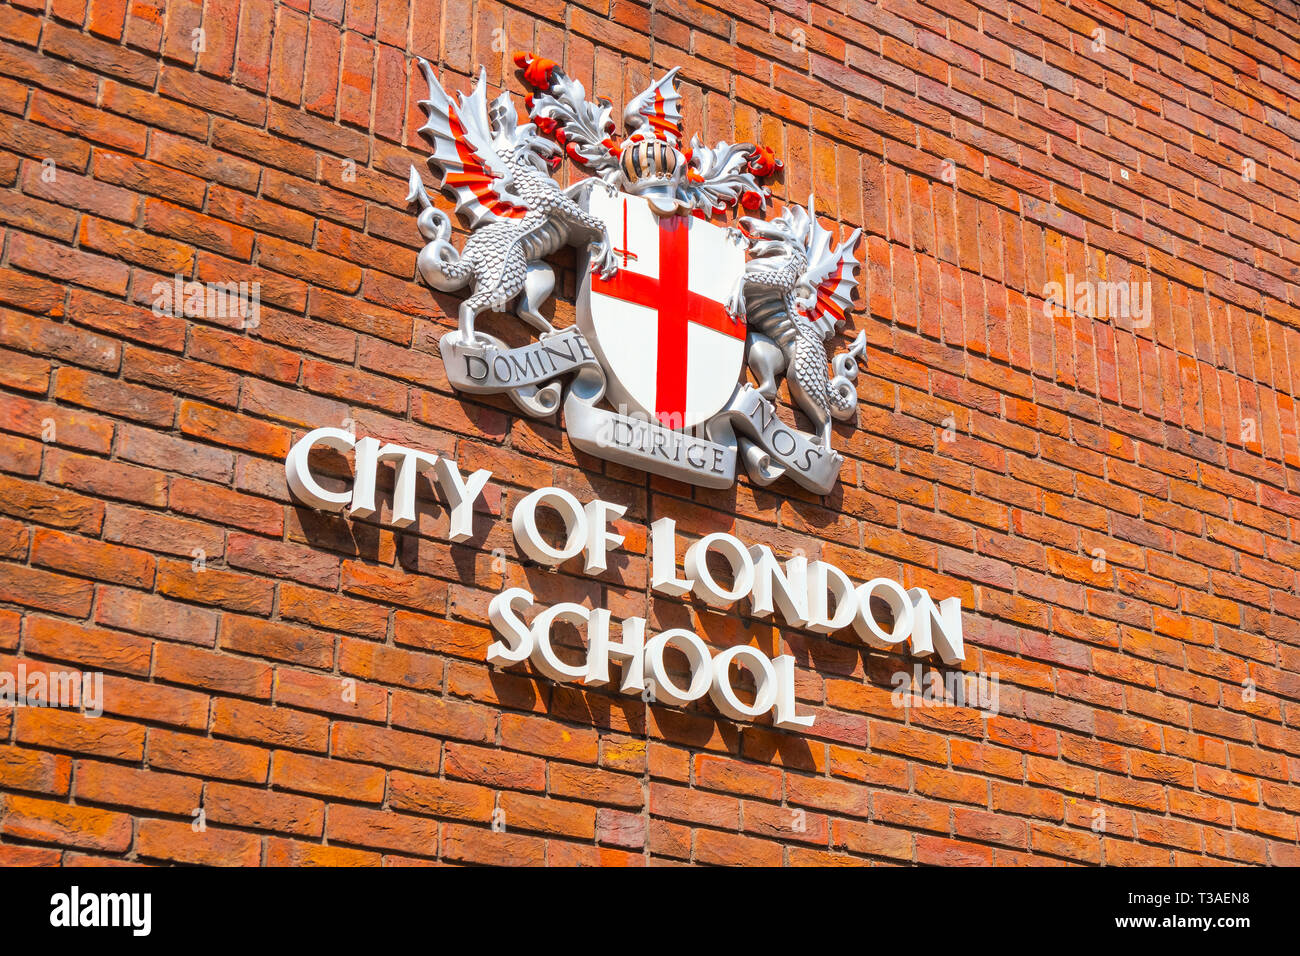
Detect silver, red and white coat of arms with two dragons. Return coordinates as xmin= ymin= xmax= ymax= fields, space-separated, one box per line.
xmin=408 ymin=53 xmax=866 ymax=494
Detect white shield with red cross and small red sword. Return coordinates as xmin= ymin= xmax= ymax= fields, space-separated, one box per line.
xmin=577 ymin=187 xmax=745 ymax=428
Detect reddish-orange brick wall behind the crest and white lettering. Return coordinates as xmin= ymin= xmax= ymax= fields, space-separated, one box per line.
xmin=0 ymin=0 xmax=1300 ymax=865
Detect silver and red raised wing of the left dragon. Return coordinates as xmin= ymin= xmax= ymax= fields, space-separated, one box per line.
xmin=420 ymin=59 xmax=528 ymax=229
